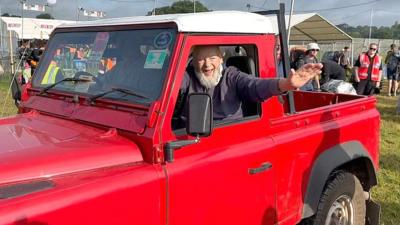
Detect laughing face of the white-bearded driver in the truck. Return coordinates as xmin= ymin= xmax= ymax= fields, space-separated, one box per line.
xmin=193 ymin=46 xmax=223 ymax=77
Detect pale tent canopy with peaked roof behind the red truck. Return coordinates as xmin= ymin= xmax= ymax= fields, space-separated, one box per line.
xmin=268 ymin=13 xmax=352 ymax=43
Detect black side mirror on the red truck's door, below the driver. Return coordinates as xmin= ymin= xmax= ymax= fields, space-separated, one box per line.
xmin=186 ymin=93 xmax=213 ymax=137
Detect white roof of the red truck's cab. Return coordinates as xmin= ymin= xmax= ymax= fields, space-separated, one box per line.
xmin=59 ymin=11 xmax=274 ymax=34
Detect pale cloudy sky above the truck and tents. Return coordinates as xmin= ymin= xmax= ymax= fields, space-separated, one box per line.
xmin=0 ymin=0 xmax=400 ymax=27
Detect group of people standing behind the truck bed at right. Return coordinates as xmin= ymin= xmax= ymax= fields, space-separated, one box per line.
xmin=290 ymin=43 xmax=400 ymax=96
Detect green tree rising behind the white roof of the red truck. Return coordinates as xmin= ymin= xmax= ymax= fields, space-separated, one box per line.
xmin=147 ymin=0 xmax=210 ymax=16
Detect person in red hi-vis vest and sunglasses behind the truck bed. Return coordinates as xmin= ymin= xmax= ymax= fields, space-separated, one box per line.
xmin=354 ymin=43 xmax=382 ymax=95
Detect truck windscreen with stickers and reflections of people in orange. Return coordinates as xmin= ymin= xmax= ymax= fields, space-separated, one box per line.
xmin=32 ymin=28 xmax=176 ymax=103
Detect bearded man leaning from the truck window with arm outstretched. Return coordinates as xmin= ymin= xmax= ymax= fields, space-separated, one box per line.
xmin=173 ymin=46 xmax=322 ymax=128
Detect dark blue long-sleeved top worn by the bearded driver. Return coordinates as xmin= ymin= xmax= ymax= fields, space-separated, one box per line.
xmin=180 ymin=66 xmax=281 ymax=125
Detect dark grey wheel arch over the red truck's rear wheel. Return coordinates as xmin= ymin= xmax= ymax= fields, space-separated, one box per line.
xmin=302 ymin=141 xmax=377 ymax=219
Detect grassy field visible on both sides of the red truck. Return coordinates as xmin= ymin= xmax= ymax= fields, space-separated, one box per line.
xmin=0 ymin=75 xmax=400 ymax=225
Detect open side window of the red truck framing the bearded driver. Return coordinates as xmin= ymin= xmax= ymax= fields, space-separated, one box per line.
xmin=171 ymin=45 xmax=261 ymax=134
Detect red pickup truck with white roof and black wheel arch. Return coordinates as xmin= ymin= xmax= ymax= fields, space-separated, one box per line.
xmin=0 ymin=11 xmax=379 ymax=225
